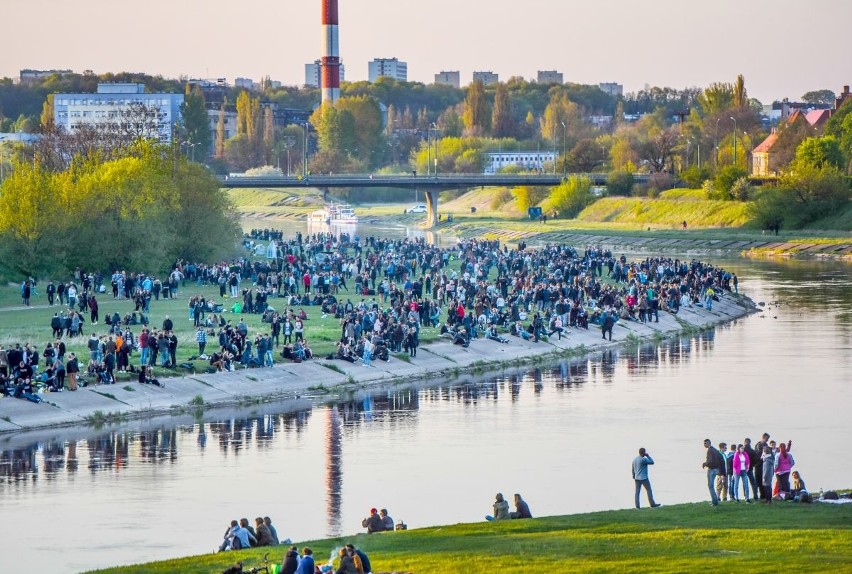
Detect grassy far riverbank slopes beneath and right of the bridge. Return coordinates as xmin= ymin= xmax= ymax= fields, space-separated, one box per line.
xmin=223 ymin=188 xmax=852 ymax=243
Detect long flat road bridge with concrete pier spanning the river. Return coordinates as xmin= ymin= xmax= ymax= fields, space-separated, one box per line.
xmin=221 ymin=172 xmax=648 ymax=227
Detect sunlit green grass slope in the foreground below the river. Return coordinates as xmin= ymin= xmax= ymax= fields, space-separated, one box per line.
xmin=88 ymin=500 xmax=852 ymax=574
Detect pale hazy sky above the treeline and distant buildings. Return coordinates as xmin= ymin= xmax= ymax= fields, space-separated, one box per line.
xmin=6 ymin=0 xmax=852 ymax=103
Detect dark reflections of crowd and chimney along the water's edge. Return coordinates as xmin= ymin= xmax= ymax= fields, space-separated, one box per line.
xmin=0 ymin=331 xmax=715 ymax=492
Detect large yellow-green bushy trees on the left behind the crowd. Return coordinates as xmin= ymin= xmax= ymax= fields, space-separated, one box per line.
xmin=0 ymin=140 xmax=239 ymax=278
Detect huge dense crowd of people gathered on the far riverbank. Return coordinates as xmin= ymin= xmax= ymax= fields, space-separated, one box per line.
xmin=0 ymin=230 xmax=737 ymax=401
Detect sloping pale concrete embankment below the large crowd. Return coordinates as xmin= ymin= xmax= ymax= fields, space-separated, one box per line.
xmin=0 ymin=295 xmax=754 ymax=436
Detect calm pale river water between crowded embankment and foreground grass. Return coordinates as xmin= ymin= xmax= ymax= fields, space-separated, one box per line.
xmin=0 ymin=231 xmax=852 ymax=572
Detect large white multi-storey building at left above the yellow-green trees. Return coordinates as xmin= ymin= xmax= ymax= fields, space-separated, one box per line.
xmin=53 ymin=83 xmax=183 ymax=142
